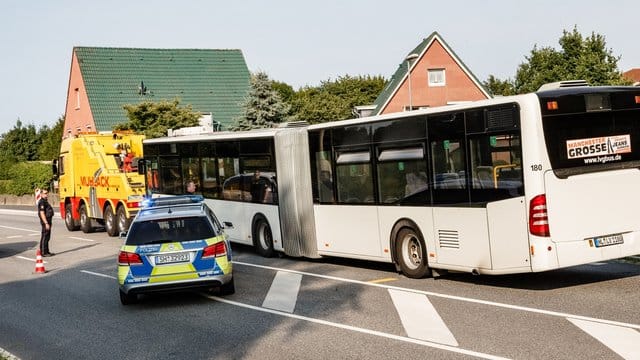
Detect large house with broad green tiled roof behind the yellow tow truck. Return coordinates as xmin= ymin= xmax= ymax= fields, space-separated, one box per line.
xmin=64 ymin=47 xmax=250 ymax=137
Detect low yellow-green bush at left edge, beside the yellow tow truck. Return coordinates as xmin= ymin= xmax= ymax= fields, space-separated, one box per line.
xmin=0 ymin=161 xmax=52 ymax=196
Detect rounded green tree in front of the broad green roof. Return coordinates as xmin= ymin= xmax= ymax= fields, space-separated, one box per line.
xmin=114 ymin=99 xmax=201 ymax=139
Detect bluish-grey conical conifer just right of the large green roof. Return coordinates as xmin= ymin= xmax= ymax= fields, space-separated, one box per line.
xmin=231 ymin=72 xmax=290 ymax=131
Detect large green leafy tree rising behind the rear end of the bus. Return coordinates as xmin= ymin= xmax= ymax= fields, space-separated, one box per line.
xmin=484 ymin=27 xmax=629 ymax=95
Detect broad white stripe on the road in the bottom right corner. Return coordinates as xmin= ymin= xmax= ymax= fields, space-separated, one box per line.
xmin=567 ymin=318 xmax=640 ymax=360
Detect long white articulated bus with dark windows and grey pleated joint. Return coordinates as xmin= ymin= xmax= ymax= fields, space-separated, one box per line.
xmin=144 ymin=86 xmax=640 ymax=278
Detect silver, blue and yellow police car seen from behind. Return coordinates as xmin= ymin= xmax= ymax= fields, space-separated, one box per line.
xmin=118 ymin=196 xmax=235 ymax=305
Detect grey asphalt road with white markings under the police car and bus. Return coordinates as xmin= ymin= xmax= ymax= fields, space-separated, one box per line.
xmin=0 ymin=209 xmax=640 ymax=359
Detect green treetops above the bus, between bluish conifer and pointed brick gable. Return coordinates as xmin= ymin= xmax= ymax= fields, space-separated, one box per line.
xmin=292 ymin=75 xmax=386 ymax=123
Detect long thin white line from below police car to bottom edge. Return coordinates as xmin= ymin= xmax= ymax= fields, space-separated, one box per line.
xmin=202 ymin=294 xmax=507 ymax=359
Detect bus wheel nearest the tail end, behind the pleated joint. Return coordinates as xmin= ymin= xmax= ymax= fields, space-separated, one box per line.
xmin=395 ymin=227 xmax=431 ymax=279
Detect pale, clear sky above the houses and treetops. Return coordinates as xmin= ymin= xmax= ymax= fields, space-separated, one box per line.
xmin=0 ymin=0 xmax=640 ymax=134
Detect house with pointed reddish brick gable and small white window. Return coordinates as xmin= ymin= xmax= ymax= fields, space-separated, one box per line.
xmin=364 ymin=32 xmax=491 ymax=116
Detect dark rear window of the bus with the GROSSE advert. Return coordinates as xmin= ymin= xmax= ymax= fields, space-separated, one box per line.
xmin=542 ymin=110 xmax=640 ymax=178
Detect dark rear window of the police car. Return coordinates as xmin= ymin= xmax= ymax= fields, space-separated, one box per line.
xmin=126 ymin=216 xmax=218 ymax=245
